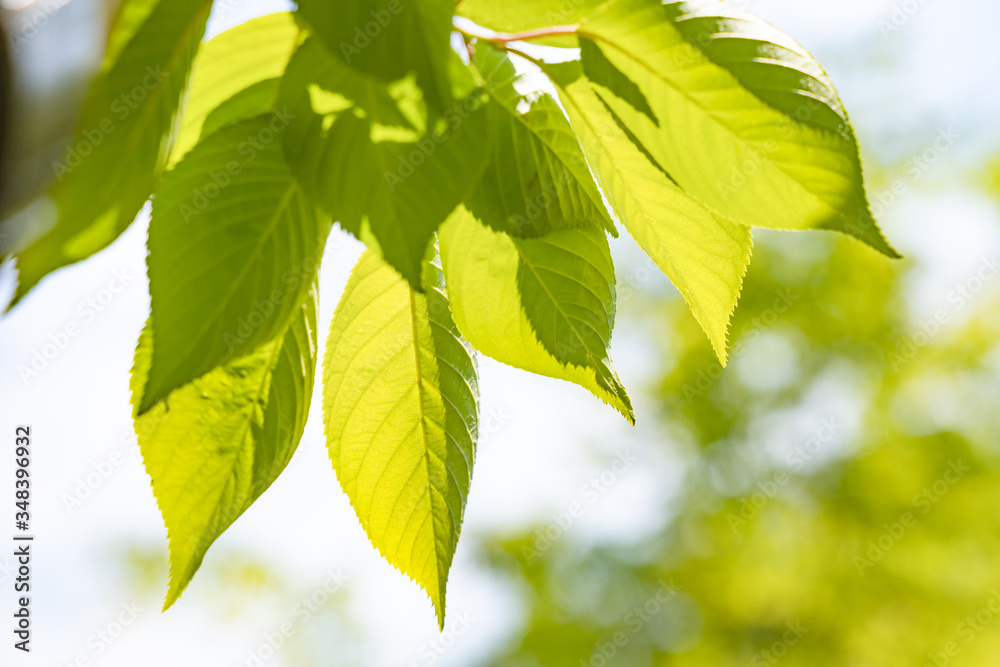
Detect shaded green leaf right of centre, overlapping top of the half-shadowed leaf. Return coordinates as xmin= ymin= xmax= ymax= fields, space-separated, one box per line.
xmin=466 ymin=42 xmax=616 ymax=237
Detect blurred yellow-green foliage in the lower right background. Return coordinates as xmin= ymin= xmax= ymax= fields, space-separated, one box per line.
xmin=476 ymin=217 xmax=1000 ymax=667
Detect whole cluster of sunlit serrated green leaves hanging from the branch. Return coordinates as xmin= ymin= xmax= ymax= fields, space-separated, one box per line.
xmin=5 ymin=0 xmax=895 ymax=624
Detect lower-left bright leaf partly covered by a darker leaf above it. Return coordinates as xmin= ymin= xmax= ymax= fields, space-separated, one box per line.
xmin=130 ymin=287 xmax=317 ymax=609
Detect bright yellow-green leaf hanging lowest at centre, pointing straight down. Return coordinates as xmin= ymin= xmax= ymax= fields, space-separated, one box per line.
xmin=323 ymin=251 xmax=479 ymax=628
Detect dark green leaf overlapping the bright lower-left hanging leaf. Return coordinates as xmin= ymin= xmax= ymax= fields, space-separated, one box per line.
xmin=139 ymin=113 xmax=330 ymax=413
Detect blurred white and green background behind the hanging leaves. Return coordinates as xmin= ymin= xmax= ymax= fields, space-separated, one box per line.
xmin=0 ymin=0 xmax=1000 ymax=667
